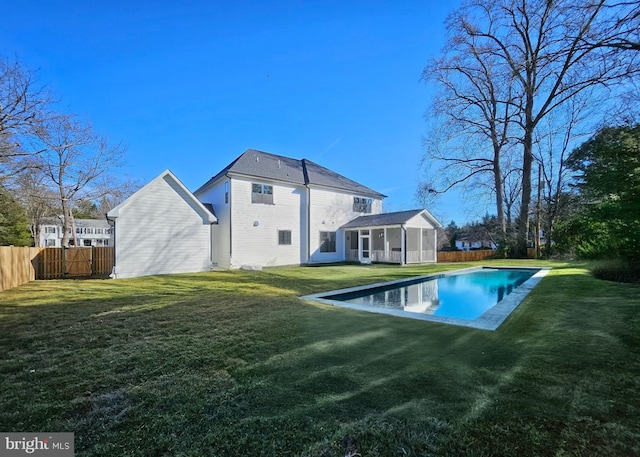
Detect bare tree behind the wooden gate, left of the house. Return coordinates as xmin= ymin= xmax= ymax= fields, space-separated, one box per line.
xmin=35 ymin=115 xmax=124 ymax=247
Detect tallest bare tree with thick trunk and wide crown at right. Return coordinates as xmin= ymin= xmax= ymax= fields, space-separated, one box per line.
xmin=424 ymin=0 xmax=638 ymax=256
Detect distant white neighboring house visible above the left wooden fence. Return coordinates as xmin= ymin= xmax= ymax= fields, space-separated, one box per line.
xmin=38 ymin=217 xmax=113 ymax=247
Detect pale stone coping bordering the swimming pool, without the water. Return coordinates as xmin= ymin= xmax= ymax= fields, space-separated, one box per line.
xmin=299 ymin=266 xmax=551 ymax=330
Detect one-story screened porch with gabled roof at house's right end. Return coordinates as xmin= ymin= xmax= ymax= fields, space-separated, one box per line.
xmin=341 ymin=209 xmax=442 ymax=265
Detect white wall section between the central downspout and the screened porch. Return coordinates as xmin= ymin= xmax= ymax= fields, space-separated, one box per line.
xmin=309 ymin=188 xmax=382 ymax=263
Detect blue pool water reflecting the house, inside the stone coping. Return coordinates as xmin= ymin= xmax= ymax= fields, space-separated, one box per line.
xmin=322 ymin=268 xmax=538 ymax=320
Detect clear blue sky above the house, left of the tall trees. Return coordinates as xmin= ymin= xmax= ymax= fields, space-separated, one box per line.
xmin=0 ymin=0 xmax=476 ymax=224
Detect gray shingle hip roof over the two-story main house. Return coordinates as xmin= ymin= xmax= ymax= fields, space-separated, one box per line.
xmin=196 ymin=149 xmax=386 ymax=198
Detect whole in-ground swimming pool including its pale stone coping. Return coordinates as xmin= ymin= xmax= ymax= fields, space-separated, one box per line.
xmin=301 ymin=267 xmax=549 ymax=330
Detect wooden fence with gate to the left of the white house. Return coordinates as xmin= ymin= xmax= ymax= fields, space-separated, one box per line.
xmin=0 ymin=246 xmax=113 ymax=291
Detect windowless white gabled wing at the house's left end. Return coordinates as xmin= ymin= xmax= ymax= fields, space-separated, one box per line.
xmin=107 ymin=170 xmax=217 ymax=278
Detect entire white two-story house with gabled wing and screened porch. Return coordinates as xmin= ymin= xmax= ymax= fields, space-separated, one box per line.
xmin=107 ymin=149 xmax=440 ymax=277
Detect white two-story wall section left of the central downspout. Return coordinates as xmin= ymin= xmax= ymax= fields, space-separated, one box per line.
xmin=231 ymin=178 xmax=307 ymax=268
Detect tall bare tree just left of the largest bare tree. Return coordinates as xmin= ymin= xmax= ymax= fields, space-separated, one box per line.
xmin=422 ymin=11 xmax=517 ymax=237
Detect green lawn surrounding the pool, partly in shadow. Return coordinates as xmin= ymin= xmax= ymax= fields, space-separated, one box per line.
xmin=0 ymin=261 xmax=640 ymax=457
